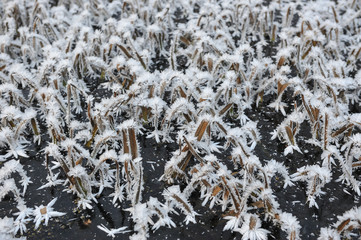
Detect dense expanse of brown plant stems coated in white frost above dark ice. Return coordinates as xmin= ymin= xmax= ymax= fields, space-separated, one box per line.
xmin=0 ymin=0 xmax=361 ymax=240
